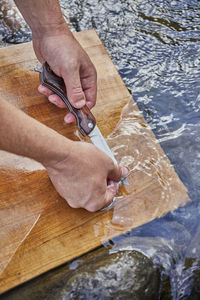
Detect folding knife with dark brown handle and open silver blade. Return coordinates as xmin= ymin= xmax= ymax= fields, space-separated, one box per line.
xmin=35 ymin=62 xmax=128 ymax=185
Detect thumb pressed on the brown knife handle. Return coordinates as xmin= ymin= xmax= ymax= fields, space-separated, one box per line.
xmin=63 ymin=70 xmax=86 ymax=108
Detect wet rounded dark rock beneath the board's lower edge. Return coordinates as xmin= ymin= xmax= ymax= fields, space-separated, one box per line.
xmin=58 ymin=251 xmax=160 ymax=300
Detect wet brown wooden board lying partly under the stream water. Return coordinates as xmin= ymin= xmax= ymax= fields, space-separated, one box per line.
xmin=0 ymin=30 xmax=189 ymax=293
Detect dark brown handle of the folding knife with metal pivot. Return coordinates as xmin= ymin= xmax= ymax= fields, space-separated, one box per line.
xmin=40 ymin=62 xmax=96 ymax=136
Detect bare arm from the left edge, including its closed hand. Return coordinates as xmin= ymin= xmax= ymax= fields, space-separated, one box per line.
xmin=0 ymin=98 xmax=126 ymax=211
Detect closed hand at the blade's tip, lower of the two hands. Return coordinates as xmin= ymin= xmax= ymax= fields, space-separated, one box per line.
xmin=45 ymin=142 xmax=128 ymax=212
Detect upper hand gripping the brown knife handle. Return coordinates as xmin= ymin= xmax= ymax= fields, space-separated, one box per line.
xmin=33 ymin=25 xmax=97 ymax=123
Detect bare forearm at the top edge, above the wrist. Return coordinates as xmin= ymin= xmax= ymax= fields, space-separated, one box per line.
xmin=15 ymin=0 xmax=71 ymax=38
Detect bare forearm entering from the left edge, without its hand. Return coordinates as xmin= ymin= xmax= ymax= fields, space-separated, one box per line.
xmin=0 ymin=98 xmax=73 ymax=165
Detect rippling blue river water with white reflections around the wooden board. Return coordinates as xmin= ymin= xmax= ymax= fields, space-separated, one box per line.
xmin=0 ymin=0 xmax=200 ymax=300
